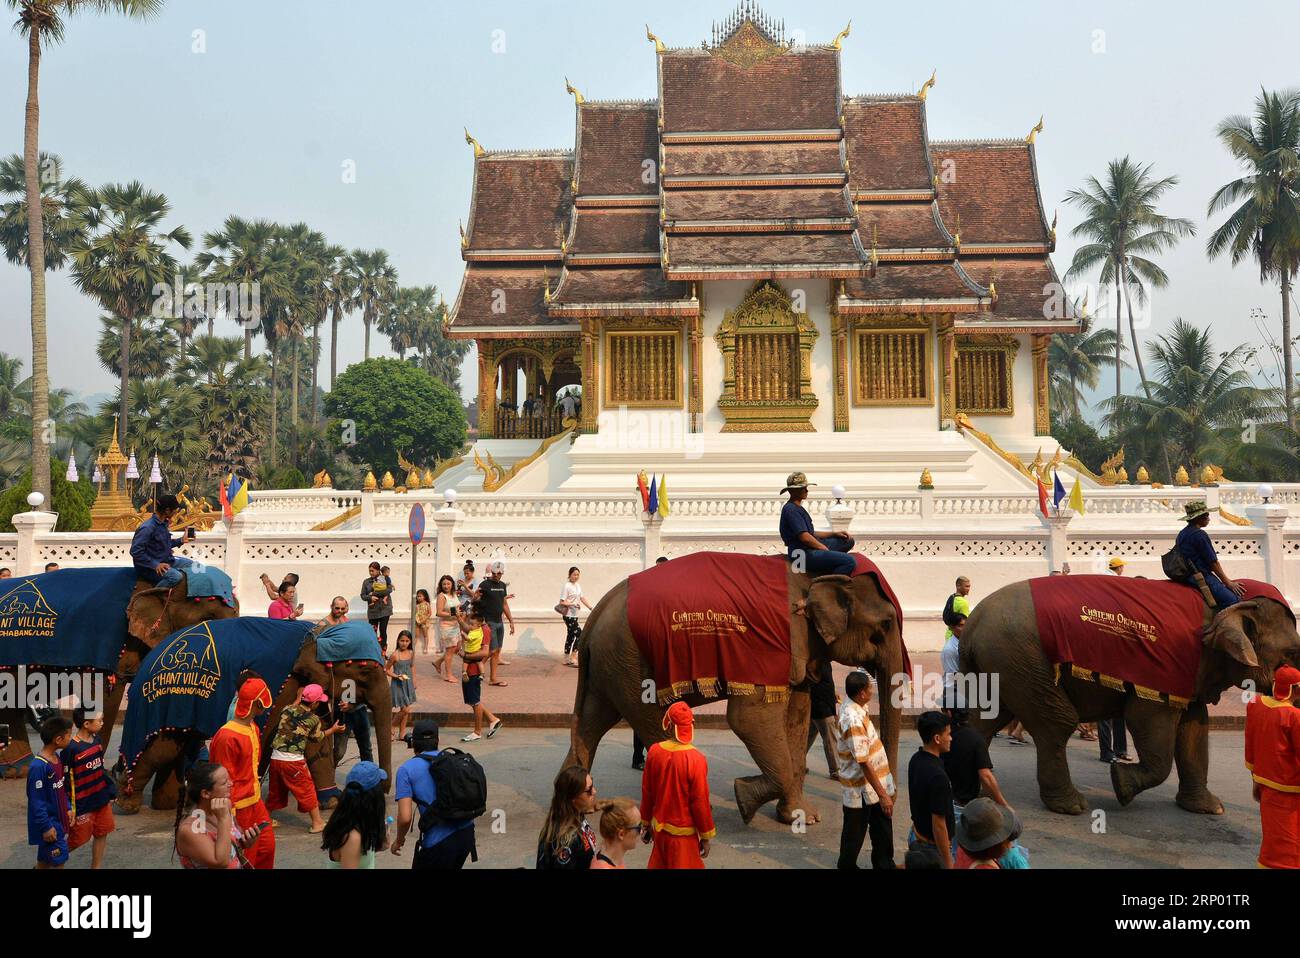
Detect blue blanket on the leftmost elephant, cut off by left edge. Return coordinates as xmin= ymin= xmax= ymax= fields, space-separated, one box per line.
xmin=0 ymin=568 xmax=135 ymax=672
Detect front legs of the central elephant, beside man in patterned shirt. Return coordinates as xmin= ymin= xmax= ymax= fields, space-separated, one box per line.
xmin=727 ymin=695 xmax=811 ymax=824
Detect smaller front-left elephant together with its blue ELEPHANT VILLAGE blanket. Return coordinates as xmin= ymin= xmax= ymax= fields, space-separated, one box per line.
xmin=113 ymin=617 xmax=393 ymax=815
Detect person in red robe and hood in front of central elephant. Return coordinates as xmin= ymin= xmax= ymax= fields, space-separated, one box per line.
xmin=641 ymin=702 xmax=718 ymax=868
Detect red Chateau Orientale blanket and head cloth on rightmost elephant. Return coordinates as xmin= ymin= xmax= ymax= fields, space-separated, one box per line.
xmin=1030 ymin=576 xmax=1291 ymax=708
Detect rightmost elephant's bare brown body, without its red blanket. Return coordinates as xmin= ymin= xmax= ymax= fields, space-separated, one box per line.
xmin=958 ymin=577 xmax=1300 ymax=815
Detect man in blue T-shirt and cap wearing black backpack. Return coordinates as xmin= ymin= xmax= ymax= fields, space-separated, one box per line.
xmin=393 ymin=719 xmax=488 ymax=870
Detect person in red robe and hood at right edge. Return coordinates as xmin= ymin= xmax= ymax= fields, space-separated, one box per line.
xmin=1245 ymin=666 xmax=1300 ymax=868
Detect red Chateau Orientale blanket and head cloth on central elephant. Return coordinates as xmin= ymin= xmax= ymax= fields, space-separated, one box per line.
xmin=628 ymin=552 xmax=911 ymax=705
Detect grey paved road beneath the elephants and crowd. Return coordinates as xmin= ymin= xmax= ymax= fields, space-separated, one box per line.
xmin=0 ymin=728 xmax=1260 ymax=868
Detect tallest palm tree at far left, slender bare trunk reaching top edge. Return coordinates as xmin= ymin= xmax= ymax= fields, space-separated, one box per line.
xmin=9 ymin=0 xmax=163 ymax=502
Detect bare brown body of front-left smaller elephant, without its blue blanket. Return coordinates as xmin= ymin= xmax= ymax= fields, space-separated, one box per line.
xmin=113 ymin=627 xmax=393 ymax=815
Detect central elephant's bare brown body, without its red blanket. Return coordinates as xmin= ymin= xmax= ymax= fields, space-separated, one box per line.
xmin=566 ymin=554 xmax=905 ymax=824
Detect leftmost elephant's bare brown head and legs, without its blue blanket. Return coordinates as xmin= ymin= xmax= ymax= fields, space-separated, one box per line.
xmin=0 ymin=571 xmax=239 ymax=777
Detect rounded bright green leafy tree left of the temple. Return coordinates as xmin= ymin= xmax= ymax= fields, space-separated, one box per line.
xmin=325 ymin=359 xmax=465 ymax=468
